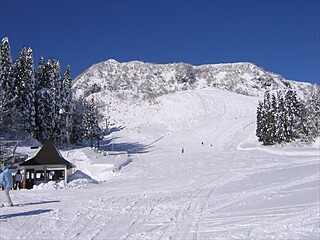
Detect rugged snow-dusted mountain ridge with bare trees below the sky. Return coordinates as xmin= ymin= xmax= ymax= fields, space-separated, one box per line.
xmin=74 ymin=60 xmax=311 ymax=101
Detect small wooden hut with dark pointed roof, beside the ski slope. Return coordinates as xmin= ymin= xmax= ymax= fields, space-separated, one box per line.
xmin=20 ymin=140 xmax=73 ymax=189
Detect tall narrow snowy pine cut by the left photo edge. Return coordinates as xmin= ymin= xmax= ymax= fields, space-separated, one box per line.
xmin=0 ymin=37 xmax=17 ymax=130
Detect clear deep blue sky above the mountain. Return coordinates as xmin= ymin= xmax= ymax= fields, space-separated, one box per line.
xmin=0 ymin=0 xmax=320 ymax=84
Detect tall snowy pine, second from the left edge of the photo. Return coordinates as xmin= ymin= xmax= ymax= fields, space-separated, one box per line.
xmin=14 ymin=47 xmax=35 ymax=134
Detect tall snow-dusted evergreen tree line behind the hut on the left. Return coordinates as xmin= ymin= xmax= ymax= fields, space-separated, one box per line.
xmin=0 ymin=37 xmax=101 ymax=144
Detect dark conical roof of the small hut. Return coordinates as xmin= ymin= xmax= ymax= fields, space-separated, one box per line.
xmin=20 ymin=140 xmax=72 ymax=166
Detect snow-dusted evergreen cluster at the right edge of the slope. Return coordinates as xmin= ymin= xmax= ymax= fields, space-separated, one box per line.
xmin=256 ymin=87 xmax=320 ymax=145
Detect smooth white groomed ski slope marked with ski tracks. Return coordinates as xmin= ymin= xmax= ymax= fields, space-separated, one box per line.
xmin=0 ymin=88 xmax=320 ymax=240
